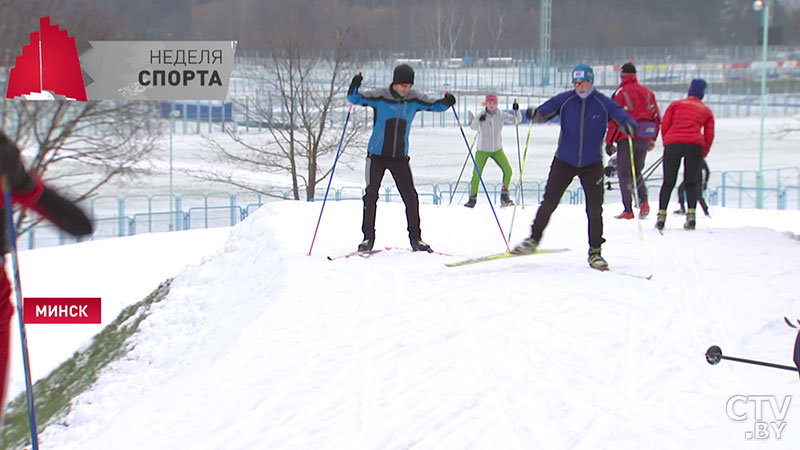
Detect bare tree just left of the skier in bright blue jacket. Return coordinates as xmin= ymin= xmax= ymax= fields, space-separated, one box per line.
xmin=198 ymin=21 xmax=363 ymax=201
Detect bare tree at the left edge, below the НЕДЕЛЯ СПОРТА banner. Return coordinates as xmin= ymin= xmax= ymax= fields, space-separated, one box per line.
xmin=0 ymin=100 xmax=160 ymax=231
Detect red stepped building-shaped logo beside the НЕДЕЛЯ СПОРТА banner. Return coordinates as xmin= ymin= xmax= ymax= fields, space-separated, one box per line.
xmin=6 ymin=16 xmax=86 ymax=102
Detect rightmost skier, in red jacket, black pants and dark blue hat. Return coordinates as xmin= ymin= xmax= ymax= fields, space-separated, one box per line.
xmin=656 ymin=79 xmax=714 ymax=231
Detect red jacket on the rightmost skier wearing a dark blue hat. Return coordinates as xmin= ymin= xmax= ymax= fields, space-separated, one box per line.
xmin=661 ymin=96 xmax=714 ymax=158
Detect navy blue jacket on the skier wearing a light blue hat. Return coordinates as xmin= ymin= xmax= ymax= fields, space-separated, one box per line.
xmin=533 ymin=89 xmax=636 ymax=167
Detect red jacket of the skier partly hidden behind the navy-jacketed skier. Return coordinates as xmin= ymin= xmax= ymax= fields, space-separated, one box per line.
xmin=606 ymin=75 xmax=661 ymax=145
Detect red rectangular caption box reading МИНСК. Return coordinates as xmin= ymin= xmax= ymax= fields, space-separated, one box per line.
xmin=22 ymin=297 xmax=101 ymax=324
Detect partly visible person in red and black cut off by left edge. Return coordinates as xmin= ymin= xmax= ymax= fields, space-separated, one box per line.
xmin=0 ymin=131 xmax=93 ymax=417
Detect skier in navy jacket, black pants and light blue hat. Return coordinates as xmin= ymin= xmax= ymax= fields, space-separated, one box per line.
xmin=512 ymin=64 xmax=636 ymax=270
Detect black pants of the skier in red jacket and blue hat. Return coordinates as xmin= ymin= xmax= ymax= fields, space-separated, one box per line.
xmin=658 ymin=143 xmax=703 ymax=212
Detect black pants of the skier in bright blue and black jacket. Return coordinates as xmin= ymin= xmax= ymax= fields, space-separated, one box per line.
xmin=361 ymin=155 xmax=422 ymax=241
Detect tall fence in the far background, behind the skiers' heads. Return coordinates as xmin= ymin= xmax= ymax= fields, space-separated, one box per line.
xmin=159 ymin=46 xmax=800 ymax=133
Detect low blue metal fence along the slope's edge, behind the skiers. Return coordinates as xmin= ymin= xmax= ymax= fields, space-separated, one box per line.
xmin=19 ymin=167 xmax=800 ymax=249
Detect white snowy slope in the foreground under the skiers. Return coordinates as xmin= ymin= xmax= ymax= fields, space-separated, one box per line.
xmin=34 ymin=201 xmax=800 ymax=450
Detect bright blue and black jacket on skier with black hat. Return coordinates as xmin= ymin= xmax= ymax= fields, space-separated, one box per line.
xmin=347 ymin=87 xmax=448 ymax=159
